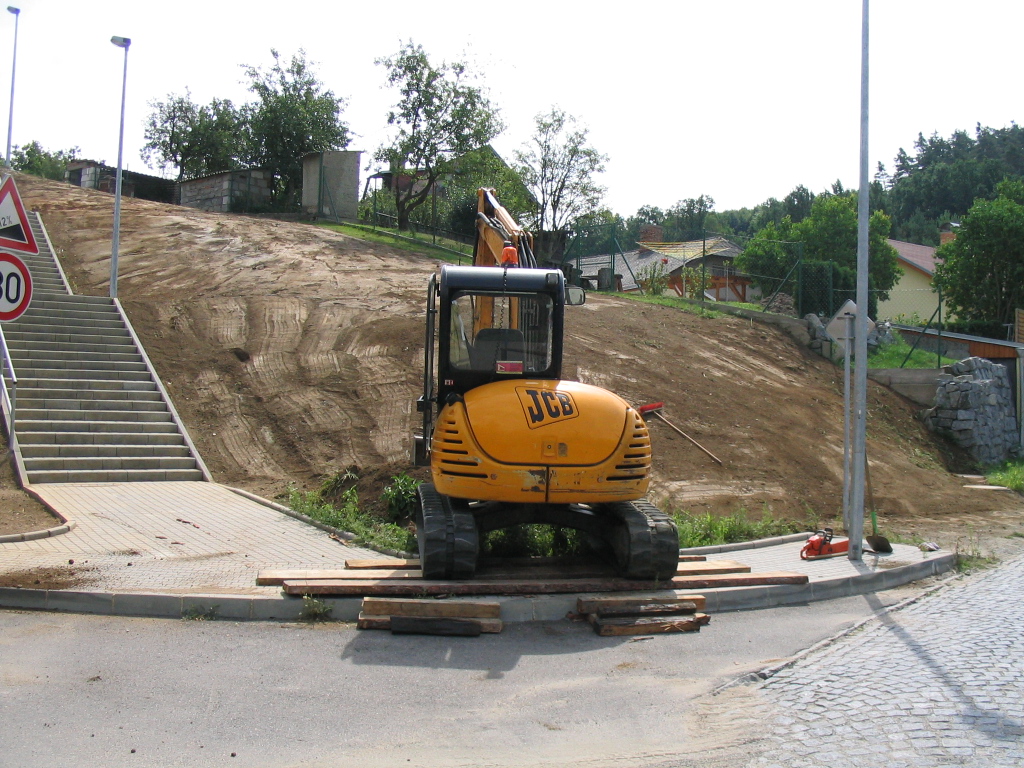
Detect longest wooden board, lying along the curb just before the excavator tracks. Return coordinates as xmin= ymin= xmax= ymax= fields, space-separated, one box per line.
xmin=284 ymin=571 xmax=808 ymax=597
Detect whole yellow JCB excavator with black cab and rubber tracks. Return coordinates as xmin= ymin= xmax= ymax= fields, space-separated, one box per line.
xmin=415 ymin=189 xmax=679 ymax=580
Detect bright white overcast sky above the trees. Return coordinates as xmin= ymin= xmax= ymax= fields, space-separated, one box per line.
xmin=0 ymin=0 xmax=1024 ymax=216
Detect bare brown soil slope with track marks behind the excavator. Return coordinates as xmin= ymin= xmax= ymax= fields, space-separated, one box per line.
xmin=17 ymin=176 xmax=1022 ymax=537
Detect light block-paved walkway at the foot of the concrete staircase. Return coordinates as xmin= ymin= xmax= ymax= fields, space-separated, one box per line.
xmin=0 ymin=482 xmax=381 ymax=595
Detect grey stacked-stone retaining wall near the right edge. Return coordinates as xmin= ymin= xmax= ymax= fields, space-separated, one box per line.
xmin=925 ymin=357 xmax=1020 ymax=465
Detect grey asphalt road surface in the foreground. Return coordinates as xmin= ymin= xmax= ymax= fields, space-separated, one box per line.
xmin=0 ymin=587 xmax=920 ymax=768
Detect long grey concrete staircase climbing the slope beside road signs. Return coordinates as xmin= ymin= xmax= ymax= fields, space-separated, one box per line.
xmin=3 ymin=213 xmax=211 ymax=483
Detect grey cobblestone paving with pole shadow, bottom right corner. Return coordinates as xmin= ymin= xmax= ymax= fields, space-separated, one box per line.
xmin=749 ymin=557 xmax=1024 ymax=768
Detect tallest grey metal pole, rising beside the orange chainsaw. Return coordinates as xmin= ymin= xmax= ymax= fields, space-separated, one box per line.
xmin=848 ymin=0 xmax=869 ymax=560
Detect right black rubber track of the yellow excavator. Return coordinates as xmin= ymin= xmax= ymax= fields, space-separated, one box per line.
xmin=597 ymin=499 xmax=679 ymax=581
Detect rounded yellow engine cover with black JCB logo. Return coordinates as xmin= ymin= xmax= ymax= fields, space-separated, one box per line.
xmin=431 ymin=379 xmax=650 ymax=512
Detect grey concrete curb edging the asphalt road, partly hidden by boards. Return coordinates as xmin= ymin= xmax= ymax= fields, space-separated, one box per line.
xmin=0 ymin=553 xmax=956 ymax=623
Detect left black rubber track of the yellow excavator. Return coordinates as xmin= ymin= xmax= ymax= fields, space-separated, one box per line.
xmin=416 ymin=482 xmax=480 ymax=580
